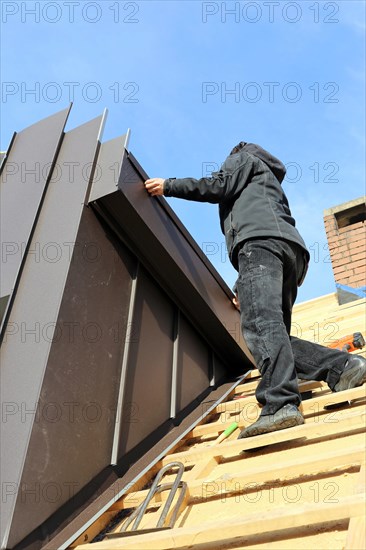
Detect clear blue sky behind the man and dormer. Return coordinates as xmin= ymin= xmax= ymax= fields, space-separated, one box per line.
xmin=0 ymin=0 xmax=365 ymax=302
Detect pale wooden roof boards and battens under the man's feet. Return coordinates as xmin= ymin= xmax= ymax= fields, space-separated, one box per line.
xmin=70 ymin=294 xmax=366 ymax=550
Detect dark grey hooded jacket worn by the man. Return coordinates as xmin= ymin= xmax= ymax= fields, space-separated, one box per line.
xmin=164 ymin=143 xmax=309 ymax=276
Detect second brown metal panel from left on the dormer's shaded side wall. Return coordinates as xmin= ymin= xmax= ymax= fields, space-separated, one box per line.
xmin=118 ymin=268 xmax=175 ymax=457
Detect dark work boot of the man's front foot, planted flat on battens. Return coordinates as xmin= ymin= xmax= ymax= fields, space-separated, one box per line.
xmin=238 ymin=404 xmax=304 ymax=439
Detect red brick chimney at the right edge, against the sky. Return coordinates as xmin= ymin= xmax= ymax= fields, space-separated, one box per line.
xmin=324 ymin=197 xmax=366 ymax=303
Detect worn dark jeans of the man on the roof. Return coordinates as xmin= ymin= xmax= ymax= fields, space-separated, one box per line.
xmin=237 ymin=238 xmax=349 ymax=415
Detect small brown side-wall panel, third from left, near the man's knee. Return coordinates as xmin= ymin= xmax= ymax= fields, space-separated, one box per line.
xmin=177 ymin=315 xmax=211 ymax=412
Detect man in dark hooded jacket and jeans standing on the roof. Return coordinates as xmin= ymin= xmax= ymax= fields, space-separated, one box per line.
xmin=144 ymin=141 xmax=366 ymax=438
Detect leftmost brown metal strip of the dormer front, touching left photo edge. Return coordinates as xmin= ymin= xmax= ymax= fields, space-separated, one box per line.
xmin=0 ymin=108 xmax=70 ymax=304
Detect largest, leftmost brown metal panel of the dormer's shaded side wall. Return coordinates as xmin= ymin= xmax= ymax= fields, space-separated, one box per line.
xmin=8 ymin=207 xmax=135 ymax=550
